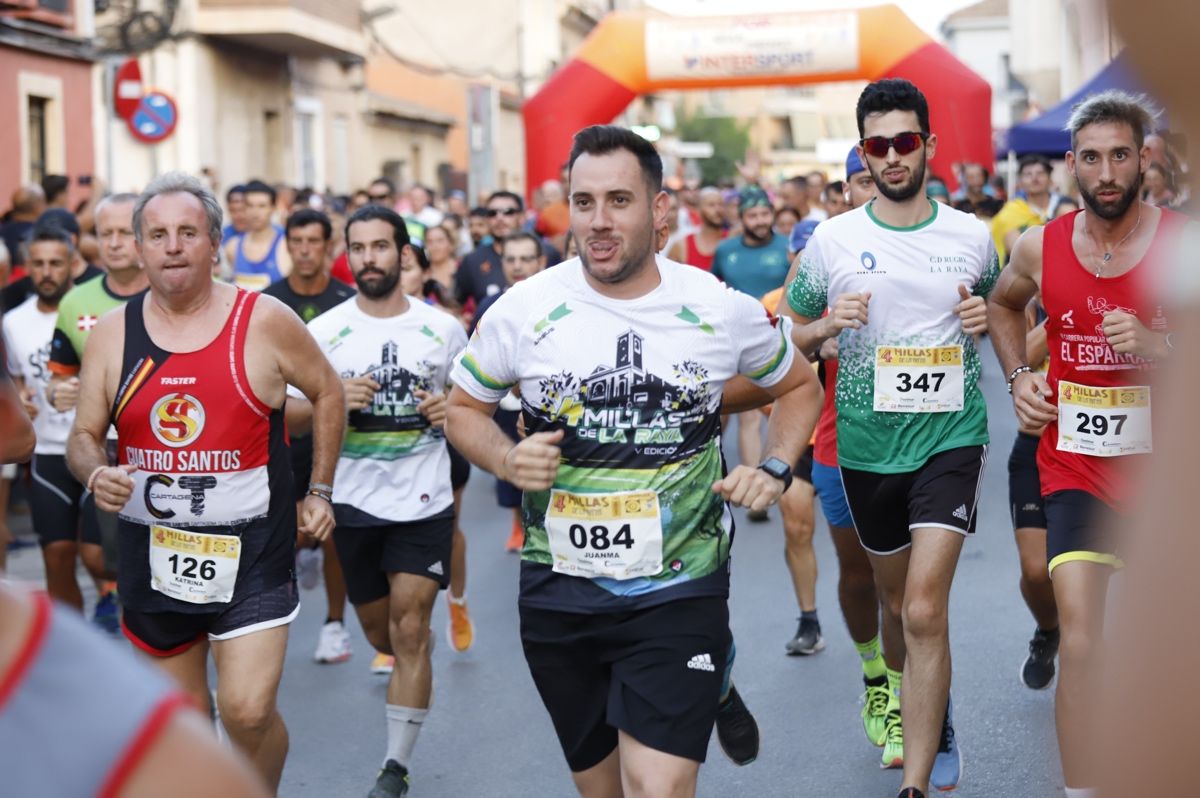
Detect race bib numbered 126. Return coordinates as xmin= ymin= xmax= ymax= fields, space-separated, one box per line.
xmin=150 ymin=524 xmax=241 ymax=604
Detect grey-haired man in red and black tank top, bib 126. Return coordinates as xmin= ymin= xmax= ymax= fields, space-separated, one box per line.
xmin=67 ymin=173 xmax=346 ymax=788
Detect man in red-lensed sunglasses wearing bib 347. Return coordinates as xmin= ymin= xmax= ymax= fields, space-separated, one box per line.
xmin=787 ymin=79 xmax=998 ymax=798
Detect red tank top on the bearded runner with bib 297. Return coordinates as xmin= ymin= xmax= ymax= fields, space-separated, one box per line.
xmin=1038 ymin=210 xmax=1187 ymax=506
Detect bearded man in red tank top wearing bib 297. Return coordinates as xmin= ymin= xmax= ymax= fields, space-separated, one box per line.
xmin=988 ymin=91 xmax=1186 ymax=798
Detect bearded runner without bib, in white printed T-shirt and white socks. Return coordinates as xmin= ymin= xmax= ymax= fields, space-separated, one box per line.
xmin=308 ymin=205 xmax=467 ymax=798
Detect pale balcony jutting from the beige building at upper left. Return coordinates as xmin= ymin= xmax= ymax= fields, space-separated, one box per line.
xmin=194 ymin=0 xmax=367 ymax=59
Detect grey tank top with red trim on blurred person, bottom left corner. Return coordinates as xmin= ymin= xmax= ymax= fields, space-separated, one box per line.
xmin=0 ymin=594 xmax=188 ymax=798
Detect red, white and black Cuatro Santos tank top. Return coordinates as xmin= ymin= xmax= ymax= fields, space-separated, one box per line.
xmin=112 ymin=289 xmax=296 ymax=613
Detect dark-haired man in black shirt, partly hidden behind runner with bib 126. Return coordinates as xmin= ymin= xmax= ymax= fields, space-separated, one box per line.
xmin=263 ymin=209 xmax=354 ymax=664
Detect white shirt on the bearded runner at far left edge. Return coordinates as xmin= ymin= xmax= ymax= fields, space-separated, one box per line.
xmin=4 ymin=294 xmax=74 ymax=455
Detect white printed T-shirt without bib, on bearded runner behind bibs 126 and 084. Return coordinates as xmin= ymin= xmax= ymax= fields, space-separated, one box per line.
xmin=308 ymin=296 xmax=467 ymax=526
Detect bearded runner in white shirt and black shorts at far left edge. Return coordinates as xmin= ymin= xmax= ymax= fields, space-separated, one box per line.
xmin=4 ymin=227 xmax=108 ymax=609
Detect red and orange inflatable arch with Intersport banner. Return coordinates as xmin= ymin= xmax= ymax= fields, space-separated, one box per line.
xmin=522 ymin=6 xmax=992 ymax=193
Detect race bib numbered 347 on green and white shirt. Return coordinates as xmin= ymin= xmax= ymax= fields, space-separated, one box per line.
xmin=875 ymin=344 xmax=964 ymax=413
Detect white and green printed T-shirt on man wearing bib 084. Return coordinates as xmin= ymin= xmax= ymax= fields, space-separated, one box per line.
xmin=452 ymin=257 xmax=794 ymax=613
